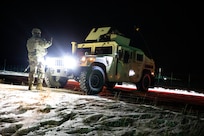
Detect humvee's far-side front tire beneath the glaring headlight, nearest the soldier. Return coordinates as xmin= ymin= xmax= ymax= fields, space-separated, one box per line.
xmin=45 ymin=69 xmax=68 ymax=88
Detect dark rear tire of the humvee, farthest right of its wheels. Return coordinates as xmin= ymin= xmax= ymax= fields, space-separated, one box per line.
xmin=136 ymin=73 xmax=151 ymax=92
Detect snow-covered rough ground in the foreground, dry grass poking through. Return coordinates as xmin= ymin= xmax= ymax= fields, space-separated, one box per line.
xmin=0 ymin=84 xmax=204 ymax=136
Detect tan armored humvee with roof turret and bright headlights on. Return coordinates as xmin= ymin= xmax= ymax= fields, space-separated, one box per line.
xmin=46 ymin=27 xmax=155 ymax=95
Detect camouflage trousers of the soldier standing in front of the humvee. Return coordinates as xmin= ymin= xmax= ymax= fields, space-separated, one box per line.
xmin=28 ymin=60 xmax=45 ymax=84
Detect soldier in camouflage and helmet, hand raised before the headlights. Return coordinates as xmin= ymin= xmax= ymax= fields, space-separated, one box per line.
xmin=26 ymin=28 xmax=52 ymax=90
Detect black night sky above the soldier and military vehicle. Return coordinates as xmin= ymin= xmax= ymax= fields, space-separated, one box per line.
xmin=0 ymin=0 xmax=204 ymax=76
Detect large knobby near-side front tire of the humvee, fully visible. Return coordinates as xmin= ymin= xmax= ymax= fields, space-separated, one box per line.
xmin=80 ymin=66 xmax=105 ymax=95
